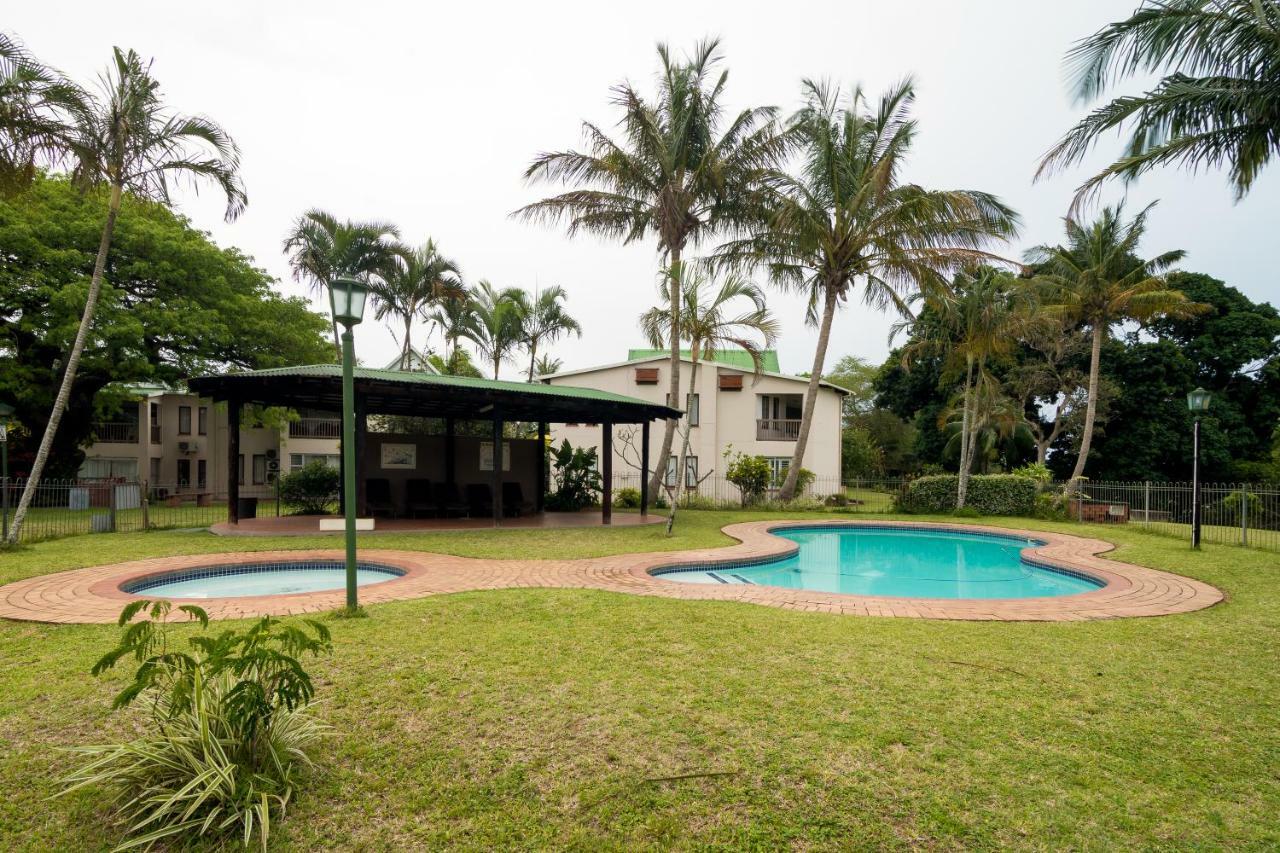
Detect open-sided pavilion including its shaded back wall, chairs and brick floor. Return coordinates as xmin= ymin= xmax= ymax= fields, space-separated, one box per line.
xmin=188 ymin=364 xmax=681 ymax=527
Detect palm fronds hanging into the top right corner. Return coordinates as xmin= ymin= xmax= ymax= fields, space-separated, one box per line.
xmin=1037 ymin=0 xmax=1280 ymax=210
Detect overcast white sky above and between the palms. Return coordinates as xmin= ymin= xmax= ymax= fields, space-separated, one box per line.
xmin=12 ymin=0 xmax=1280 ymax=377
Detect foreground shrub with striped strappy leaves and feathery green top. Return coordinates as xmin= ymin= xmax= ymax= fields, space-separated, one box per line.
xmin=63 ymin=601 xmax=332 ymax=849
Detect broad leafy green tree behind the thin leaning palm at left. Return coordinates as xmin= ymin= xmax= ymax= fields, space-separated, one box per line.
xmin=0 ymin=174 xmax=332 ymax=476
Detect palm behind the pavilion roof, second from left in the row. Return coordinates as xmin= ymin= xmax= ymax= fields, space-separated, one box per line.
xmin=372 ymin=240 xmax=466 ymax=370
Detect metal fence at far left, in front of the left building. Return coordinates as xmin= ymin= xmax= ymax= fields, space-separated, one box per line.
xmin=0 ymin=478 xmax=288 ymax=542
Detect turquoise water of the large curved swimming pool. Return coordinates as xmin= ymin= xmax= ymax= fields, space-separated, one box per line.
xmin=658 ymin=526 xmax=1103 ymax=598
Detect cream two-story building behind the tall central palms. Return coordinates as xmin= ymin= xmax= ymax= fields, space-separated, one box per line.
xmin=541 ymin=350 xmax=847 ymax=488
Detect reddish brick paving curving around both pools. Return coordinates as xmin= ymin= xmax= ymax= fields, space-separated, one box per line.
xmin=0 ymin=520 xmax=1224 ymax=622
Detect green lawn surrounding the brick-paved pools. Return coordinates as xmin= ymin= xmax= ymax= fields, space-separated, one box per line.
xmin=0 ymin=512 xmax=1280 ymax=850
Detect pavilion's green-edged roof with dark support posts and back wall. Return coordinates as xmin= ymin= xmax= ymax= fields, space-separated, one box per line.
xmin=187 ymin=364 xmax=681 ymax=525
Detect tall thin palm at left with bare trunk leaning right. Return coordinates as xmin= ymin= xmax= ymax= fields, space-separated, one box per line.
xmin=9 ymin=47 xmax=246 ymax=542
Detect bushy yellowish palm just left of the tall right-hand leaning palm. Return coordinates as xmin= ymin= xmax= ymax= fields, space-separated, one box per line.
xmin=896 ymin=266 xmax=1036 ymax=507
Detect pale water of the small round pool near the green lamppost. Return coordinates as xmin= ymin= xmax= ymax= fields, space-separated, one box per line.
xmin=120 ymin=560 xmax=404 ymax=598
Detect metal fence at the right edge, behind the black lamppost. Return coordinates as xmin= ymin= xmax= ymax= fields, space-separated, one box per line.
xmin=1068 ymin=480 xmax=1280 ymax=551
